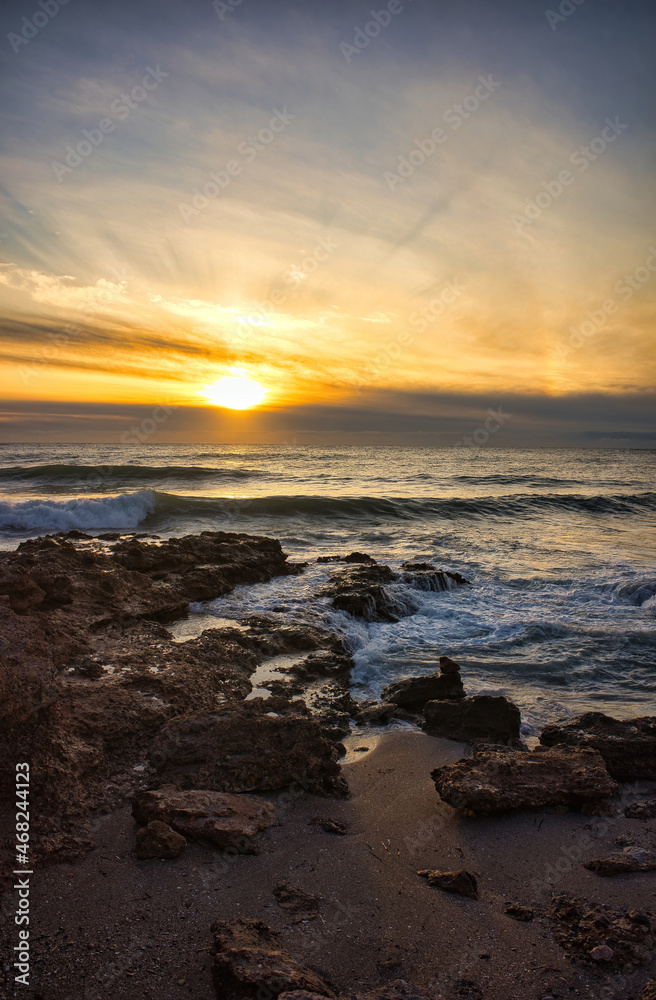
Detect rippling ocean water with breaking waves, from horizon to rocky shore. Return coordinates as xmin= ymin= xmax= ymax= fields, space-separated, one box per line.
xmin=0 ymin=444 xmax=656 ymax=734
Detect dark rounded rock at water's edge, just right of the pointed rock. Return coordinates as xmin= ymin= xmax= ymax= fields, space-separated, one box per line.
xmin=422 ymin=696 xmax=521 ymax=743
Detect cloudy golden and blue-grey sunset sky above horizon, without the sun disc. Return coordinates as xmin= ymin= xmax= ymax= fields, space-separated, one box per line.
xmin=0 ymin=0 xmax=656 ymax=446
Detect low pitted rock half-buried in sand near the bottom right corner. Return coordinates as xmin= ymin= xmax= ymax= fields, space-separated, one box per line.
xmin=547 ymin=896 xmax=656 ymax=969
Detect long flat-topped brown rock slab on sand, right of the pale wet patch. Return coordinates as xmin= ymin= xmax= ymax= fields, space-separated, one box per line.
xmin=431 ymin=747 xmax=617 ymax=816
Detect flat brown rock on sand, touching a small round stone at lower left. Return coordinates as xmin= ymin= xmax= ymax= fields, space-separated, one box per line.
xmin=132 ymin=788 xmax=278 ymax=854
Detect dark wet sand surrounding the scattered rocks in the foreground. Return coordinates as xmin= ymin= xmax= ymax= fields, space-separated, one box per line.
xmin=6 ymin=727 xmax=656 ymax=1000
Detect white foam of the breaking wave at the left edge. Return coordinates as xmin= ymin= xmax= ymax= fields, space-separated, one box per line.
xmin=0 ymin=490 xmax=155 ymax=534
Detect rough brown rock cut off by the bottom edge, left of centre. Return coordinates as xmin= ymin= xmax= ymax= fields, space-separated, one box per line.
xmin=211 ymin=917 xmax=335 ymax=1000
